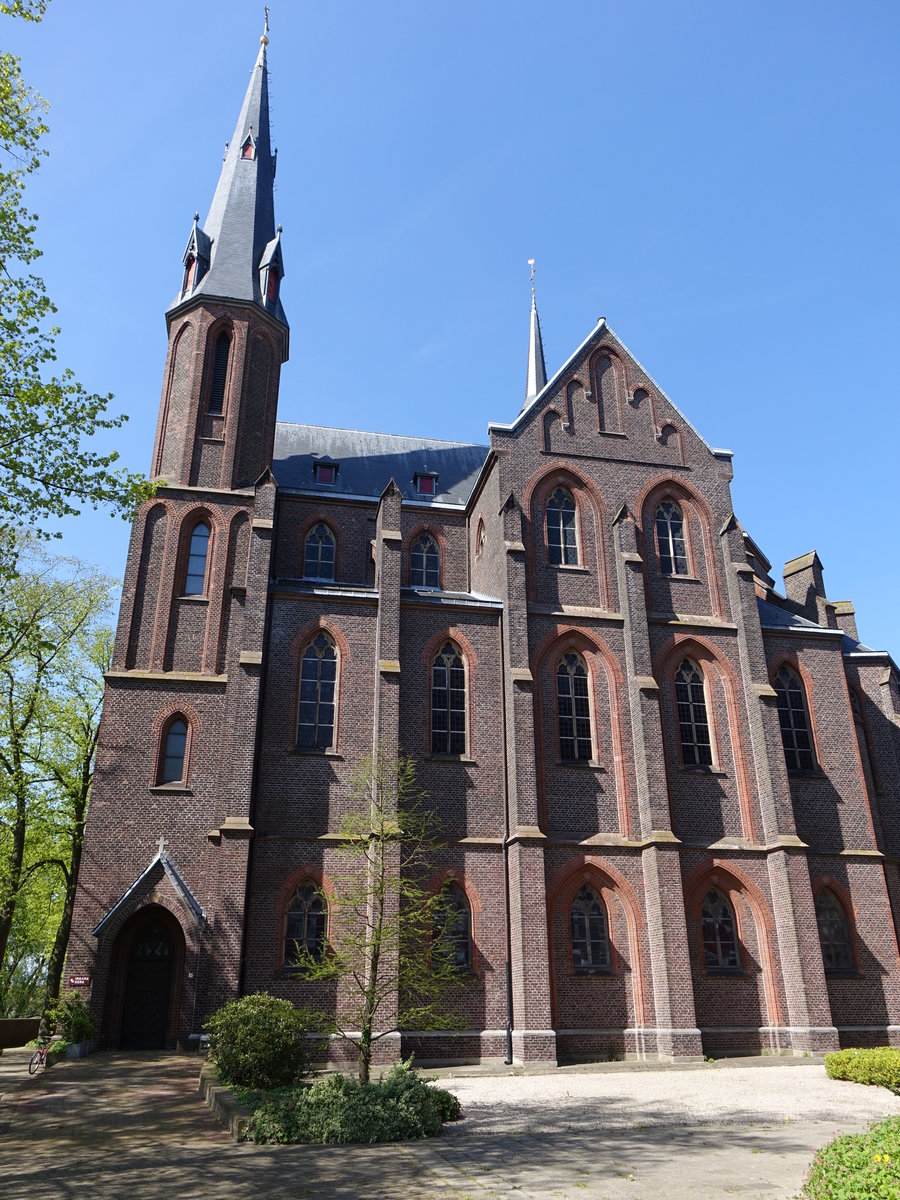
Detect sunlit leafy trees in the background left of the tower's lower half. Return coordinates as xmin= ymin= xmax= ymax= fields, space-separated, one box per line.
xmin=0 ymin=544 xmax=112 ymax=1008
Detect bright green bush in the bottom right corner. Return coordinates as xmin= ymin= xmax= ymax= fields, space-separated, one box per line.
xmin=800 ymin=1108 xmax=900 ymax=1200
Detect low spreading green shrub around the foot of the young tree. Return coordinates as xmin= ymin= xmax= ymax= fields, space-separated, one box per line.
xmin=246 ymin=1063 xmax=462 ymax=1145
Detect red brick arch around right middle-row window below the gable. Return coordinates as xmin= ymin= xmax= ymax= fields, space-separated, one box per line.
xmin=653 ymin=632 xmax=755 ymax=840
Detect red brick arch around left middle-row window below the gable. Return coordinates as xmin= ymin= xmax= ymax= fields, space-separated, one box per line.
xmin=532 ymin=625 xmax=631 ymax=836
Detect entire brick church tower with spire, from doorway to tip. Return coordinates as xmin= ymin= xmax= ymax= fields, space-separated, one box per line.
xmin=68 ymin=23 xmax=288 ymax=1048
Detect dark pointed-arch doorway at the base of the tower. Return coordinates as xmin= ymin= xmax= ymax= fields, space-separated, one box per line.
xmin=110 ymin=905 xmax=185 ymax=1050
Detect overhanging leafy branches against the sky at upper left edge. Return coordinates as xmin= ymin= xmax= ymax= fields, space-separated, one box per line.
xmin=0 ymin=0 xmax=152 ymax=581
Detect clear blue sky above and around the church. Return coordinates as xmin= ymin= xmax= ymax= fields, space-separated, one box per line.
xmin=7 ymin=0 xmax=900 ymax=656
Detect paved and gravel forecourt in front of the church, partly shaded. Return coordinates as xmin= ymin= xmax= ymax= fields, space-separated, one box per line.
xmin=0 ymin=1050 xmax=900 ymax=1200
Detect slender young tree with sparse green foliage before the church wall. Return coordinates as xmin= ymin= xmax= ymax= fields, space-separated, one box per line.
xmin=296 ymin=748 xmax=464 ymax=1084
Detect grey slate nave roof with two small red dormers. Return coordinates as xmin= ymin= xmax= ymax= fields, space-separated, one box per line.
xmin=272 ymin=421 xmax=488 ymax=504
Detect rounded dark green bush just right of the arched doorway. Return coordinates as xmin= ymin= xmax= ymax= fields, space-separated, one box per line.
xmin=204 ymin=992 xmax=324 ymax=1088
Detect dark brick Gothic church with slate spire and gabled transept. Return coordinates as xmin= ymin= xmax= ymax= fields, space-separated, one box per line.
xmin=67 ymin=28 xmax=900 ymax=1063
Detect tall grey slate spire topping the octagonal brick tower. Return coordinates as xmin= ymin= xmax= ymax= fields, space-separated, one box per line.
xmin=172 ymin=19 xmax=287 ymax=325
